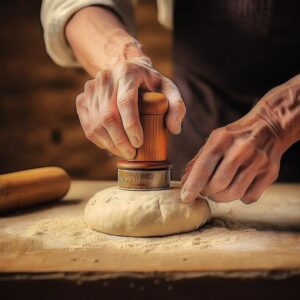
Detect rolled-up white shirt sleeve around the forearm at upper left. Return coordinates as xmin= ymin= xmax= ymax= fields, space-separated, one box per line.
xmin=41 ymin=0 xmax=134 ymax=67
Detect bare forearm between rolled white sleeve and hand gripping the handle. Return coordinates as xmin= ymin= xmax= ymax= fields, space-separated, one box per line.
xmin=66 ymin=6 xmax=145 ymax=77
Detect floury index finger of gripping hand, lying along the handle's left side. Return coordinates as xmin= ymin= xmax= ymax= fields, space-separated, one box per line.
xmin=117 ymin=77 xmax=143 ymax=148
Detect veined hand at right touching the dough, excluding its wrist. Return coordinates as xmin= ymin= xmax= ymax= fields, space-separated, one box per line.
xmin=181 ymin=102 xmax=283 ymax=204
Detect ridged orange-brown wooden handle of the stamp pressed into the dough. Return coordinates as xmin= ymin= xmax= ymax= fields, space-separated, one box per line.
xmin=134 ymin=92 xmax=168 ymax=161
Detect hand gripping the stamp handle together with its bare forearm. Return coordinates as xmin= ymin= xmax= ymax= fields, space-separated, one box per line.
xmin=66 ymin=6 xmax=185 ymax=159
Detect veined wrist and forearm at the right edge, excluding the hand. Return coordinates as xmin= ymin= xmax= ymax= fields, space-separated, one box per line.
xmin=250 ymin=75 xmax=300 ymax=151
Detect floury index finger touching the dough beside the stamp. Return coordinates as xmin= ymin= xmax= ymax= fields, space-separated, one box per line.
xmin=180 ymin=147 xmax=222 ymax=203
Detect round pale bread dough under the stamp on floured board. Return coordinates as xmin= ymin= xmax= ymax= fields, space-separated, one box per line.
xmin=85 ymin=186 xmax=210 ymax=237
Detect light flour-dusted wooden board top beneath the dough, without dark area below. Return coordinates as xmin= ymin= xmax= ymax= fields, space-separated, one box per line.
xmin=0 ymin=181 xmax=300 ymax=276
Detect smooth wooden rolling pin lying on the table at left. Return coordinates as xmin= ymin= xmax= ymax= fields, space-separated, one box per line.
xmin=0 ymin=167 xmax=71 ymax=212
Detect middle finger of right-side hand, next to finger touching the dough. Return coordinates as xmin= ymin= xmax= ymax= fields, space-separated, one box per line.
xmin=201 ymin=145 xmax=254 ymax=197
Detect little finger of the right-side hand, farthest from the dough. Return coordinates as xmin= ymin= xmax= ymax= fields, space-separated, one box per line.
xmin=241 ymin=164 xmax=278 ymax=204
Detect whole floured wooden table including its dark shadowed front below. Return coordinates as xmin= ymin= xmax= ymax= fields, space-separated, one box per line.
xmin=0 ymin=181 xmax=300 ymax=299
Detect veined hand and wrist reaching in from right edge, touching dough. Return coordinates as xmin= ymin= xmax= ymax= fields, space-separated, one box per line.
xmin=181 ymin=76 xmax=300 ymax=204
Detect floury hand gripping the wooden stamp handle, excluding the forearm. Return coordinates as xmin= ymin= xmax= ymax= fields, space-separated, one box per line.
xmin=76 ymin=57 xmax=186 ymax=159
